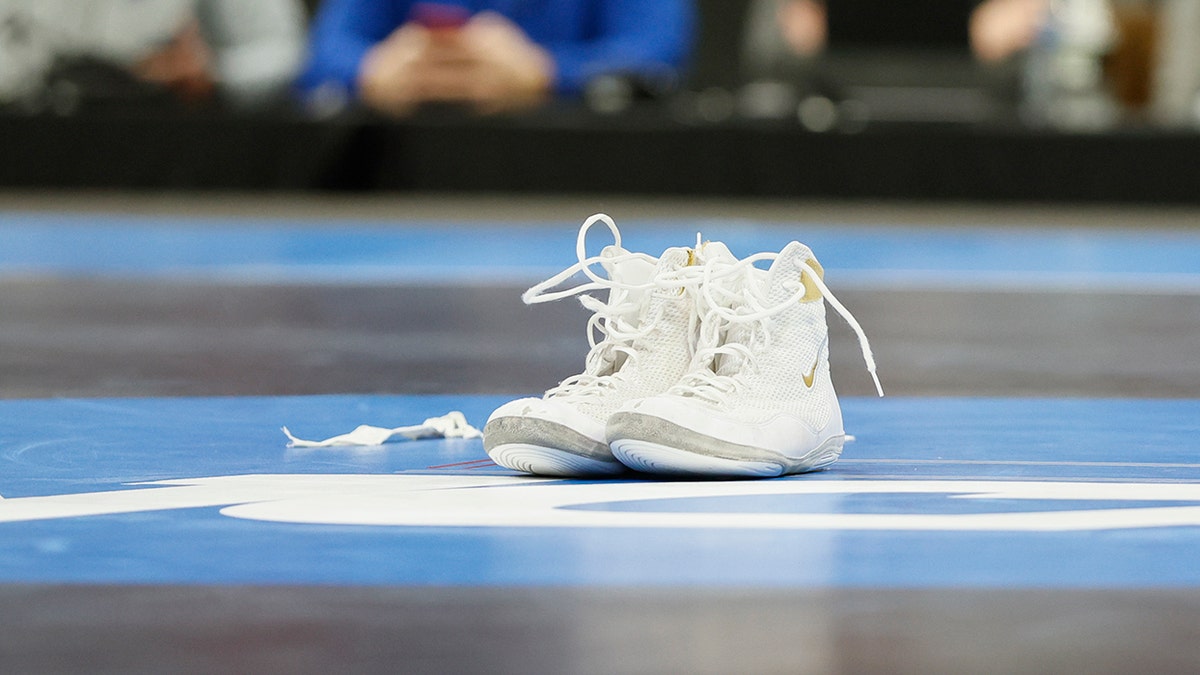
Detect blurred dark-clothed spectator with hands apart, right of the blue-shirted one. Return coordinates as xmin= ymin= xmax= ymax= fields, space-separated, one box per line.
xmin=736 ymin=0 xmax=1022 ymax=124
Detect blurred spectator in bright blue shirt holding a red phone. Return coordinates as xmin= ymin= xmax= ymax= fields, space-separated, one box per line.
xmin=301 ymin=0 xmax=695 ymax=115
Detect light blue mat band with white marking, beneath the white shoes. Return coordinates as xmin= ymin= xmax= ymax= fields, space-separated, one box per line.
xmin=0 ymin=396 xmax=1200 ymax=587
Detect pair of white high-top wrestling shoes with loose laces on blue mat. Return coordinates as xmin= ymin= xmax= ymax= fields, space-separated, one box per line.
xmin=484 ymin=214 xmax=883 ymax=478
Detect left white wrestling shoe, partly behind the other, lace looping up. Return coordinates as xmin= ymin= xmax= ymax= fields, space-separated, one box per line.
xmin=484 ymin=214 xmax=734 ymax=477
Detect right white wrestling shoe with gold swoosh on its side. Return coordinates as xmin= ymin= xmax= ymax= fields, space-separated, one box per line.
xmin=607 ymin=241 xmax=883 ymax=478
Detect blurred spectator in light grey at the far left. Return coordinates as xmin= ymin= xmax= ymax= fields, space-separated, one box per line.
xmin=0 ymin=0 xmax=306 ymax=112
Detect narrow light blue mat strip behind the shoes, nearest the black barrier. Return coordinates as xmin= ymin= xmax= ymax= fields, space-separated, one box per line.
xmin=0 ymin=213 xmax=1200 ymax=293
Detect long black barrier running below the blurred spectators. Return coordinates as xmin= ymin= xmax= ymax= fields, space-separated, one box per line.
xmin=0 ymin=109 xmax=1200 ymax=204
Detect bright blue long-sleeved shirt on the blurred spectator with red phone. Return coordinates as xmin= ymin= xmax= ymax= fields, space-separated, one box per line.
xmin=300 ymin=0 xmax=695 ymax=95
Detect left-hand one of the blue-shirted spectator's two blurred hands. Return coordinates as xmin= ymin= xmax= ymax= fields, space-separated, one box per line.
xmin=359 ymin=23 xmax=430 ymax=115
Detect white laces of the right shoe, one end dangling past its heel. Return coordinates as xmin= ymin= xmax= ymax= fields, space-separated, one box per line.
xmin=672 ymin=253 xmax=883 ymax=402
